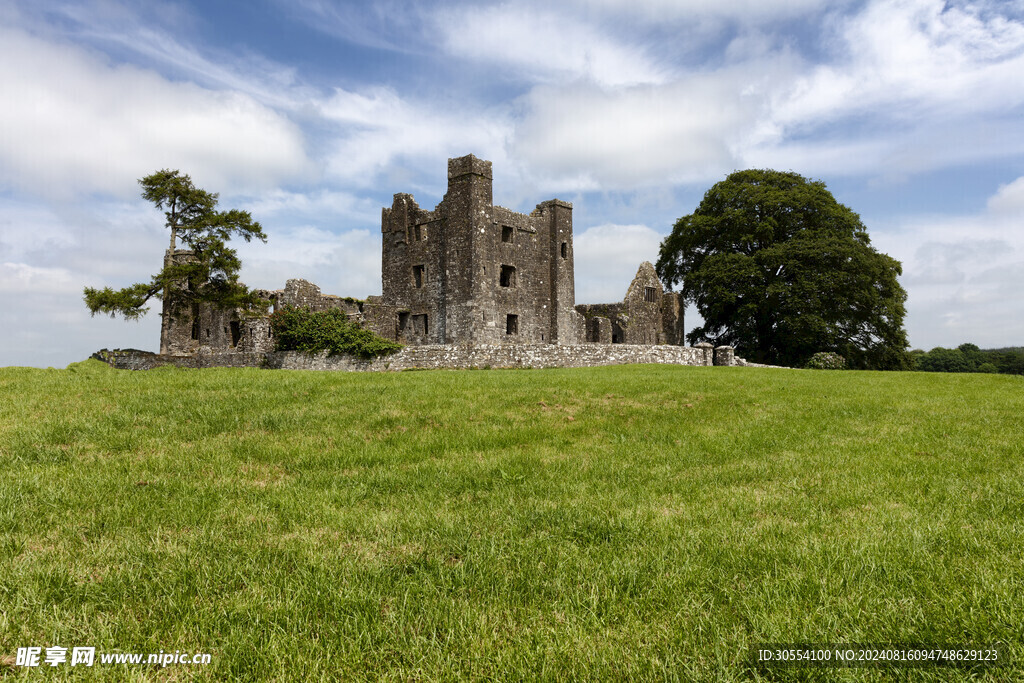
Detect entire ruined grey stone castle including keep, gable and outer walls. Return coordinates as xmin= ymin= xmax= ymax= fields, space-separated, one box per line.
xmin=128 ymin=155 xmax=741 ymax=369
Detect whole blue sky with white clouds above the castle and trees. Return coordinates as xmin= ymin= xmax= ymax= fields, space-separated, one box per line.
xmin=0 ymin=0 xmax=1024 ymax=367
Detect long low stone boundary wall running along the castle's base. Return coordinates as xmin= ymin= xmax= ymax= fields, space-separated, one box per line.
xmin=92 ymin=344 xmax=745 ymax=372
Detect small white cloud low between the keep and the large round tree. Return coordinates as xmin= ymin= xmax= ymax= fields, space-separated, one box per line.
xmin=572 ymin=224 xmax=663 ymax=303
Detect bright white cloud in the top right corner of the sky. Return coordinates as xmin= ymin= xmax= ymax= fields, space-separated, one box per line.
xmin=775 ymin=0 xmax=1024 ymax=126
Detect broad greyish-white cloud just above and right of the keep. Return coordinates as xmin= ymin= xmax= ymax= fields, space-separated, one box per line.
xmin=512 ymin=71 xmax=782 ymax=189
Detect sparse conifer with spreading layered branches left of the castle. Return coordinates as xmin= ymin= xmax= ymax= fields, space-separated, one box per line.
xmin=84 ymin=169 xmax=266 ymax=319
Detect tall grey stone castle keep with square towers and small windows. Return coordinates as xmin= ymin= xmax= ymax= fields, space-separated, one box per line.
xmin=364 ymin=155 xmax=583 ymax=345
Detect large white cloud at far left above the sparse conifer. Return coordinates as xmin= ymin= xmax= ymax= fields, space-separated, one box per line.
xmin=0 ymin=30 xmax=309 ymax=198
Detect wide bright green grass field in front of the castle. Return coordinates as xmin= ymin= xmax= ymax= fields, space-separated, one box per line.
xmin=0 ymin=361 xmax=1024 ymax=681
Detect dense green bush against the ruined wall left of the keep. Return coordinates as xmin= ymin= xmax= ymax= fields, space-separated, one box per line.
xmin=270 ymin=306 xmax=401 ymax=358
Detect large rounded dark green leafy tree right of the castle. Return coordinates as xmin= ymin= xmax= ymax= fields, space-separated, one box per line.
xmin=656 ymin=170 xmax=909 ymax=369
